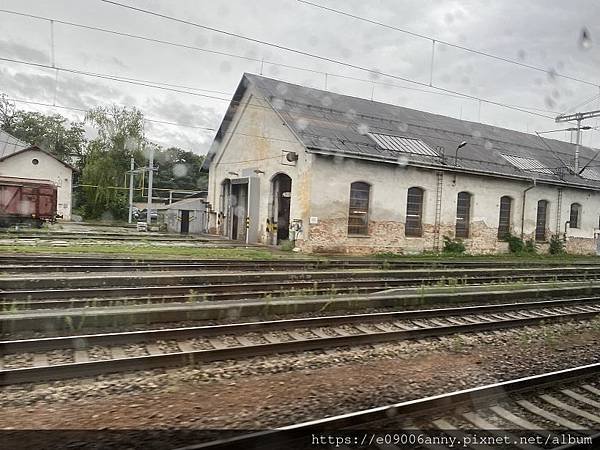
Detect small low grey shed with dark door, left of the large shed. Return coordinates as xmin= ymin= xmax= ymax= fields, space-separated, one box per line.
xmin=158 ymin=198 xmax=208 ymax=234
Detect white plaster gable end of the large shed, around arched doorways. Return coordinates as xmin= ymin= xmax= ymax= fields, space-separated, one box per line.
xmin=208 ymin=88 xmax=312 ymax=243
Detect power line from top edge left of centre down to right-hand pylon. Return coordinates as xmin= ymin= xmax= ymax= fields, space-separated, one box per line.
xmin=100 ymin=0 xmax=554 ymax=119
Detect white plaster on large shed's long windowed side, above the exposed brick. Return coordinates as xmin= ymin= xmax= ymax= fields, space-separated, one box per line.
xmin=309 ymin=156 xmax=600 ymax=250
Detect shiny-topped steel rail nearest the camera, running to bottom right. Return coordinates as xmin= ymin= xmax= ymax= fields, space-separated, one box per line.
xmin=178 ymin=363 xmax=600 ymax=450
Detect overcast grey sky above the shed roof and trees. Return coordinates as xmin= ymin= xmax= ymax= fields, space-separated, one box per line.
xmin=0 ymin=0 xmax=600 ymax=154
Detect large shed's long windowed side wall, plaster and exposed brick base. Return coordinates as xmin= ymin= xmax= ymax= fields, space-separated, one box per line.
xmin=299 ymin=156 xmax=600 ymax=254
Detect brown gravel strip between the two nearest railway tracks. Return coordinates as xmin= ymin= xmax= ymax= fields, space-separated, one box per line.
xmin=0 ymin=321 xmax=600 ymax=448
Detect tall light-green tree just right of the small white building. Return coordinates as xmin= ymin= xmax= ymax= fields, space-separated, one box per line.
xmin=79 ymin=105 xmax=146 ymax=219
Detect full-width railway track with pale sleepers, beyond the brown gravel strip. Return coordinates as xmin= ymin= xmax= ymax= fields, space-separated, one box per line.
xmin=0 ymin=299 xmax=600 ymax=385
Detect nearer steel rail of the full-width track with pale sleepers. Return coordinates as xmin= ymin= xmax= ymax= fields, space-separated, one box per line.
xmin=0 ymin=304 xmax=600 ymax=386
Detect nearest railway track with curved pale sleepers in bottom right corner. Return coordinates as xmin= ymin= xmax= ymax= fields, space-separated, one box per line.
xmin=189 ymin=363 xmax=600 ymax=450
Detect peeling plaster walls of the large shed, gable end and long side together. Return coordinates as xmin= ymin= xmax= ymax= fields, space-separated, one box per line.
xmin=208 ymin=92 xmax=600 ymax=254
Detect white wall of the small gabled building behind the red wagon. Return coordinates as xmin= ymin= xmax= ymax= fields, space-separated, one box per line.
xmin=0 ymin=149 xmax=73 ymax=220
